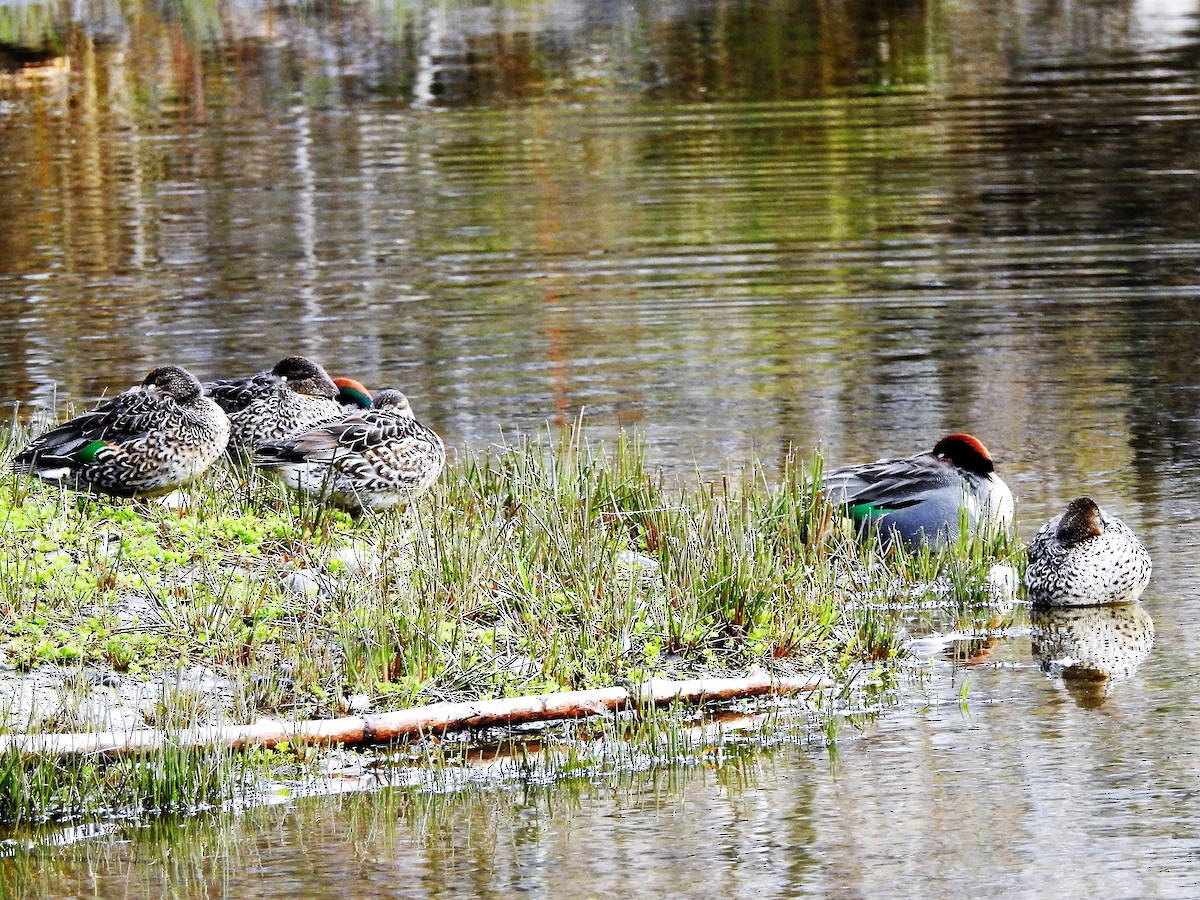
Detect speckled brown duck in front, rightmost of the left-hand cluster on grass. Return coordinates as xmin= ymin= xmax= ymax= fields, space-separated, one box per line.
xmin=254 ymin=390 xmax=446 ymax=515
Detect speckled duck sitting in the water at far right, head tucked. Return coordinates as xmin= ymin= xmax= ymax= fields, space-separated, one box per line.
xmin=1025 ymin=497 xmax=1151 ymax=606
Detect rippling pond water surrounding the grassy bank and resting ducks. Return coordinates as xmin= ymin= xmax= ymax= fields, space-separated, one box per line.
xmin=0 ymin=0 xmax=1200 ymax=896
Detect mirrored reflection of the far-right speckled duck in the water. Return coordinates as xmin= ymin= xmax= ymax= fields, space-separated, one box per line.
xmin=1030 ymin=604 xmax=1154 ymax=707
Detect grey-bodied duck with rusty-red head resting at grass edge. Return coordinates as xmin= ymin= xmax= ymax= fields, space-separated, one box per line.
xmin=822 ymin=433 xmax=1013 ymax=548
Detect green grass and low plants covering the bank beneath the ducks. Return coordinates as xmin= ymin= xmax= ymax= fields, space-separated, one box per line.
xmin=0 ymin=422 xmax=1015 ymax=822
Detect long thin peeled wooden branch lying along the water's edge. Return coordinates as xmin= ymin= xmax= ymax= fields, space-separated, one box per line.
xmin=0 ymin=672 xmax=827 ymax=756
